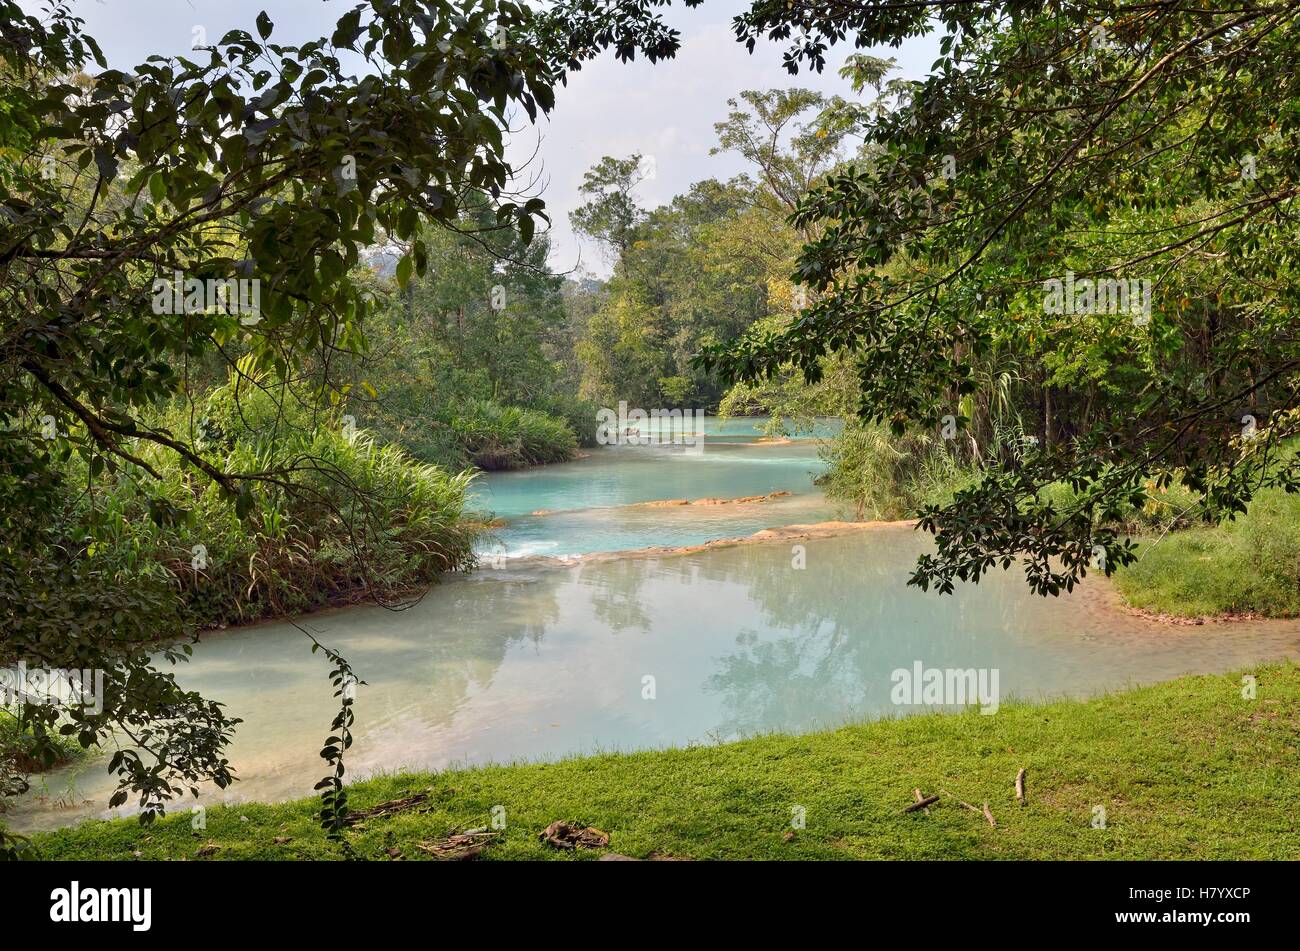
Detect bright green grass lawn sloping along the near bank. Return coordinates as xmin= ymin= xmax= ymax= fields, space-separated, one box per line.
xmin=22 ymin=664 xmax=1300 ymax=860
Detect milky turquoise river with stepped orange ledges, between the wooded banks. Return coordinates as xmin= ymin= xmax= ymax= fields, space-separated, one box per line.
xmin=9 ymin=431 xmax=1300 ymax=830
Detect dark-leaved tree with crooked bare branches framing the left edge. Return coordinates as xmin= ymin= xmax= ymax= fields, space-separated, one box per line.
xmin=0 ymin=0 xmax=663 ymax=844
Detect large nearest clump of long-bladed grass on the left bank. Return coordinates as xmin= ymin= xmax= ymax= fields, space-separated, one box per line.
xmin=67 ymin=374 xmax=480 ymax=634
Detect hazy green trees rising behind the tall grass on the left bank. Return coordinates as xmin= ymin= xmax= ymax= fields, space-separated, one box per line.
xmin=339 ymin=218 xmax=595 ymax=469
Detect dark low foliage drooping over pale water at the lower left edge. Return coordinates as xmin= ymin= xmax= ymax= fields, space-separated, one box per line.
xmin=0 ymin=438 xmax=238 ymax=826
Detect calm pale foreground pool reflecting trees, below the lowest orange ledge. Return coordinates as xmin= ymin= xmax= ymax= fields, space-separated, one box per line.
xmin=9 ymin=527 xmax=1300 ymax=829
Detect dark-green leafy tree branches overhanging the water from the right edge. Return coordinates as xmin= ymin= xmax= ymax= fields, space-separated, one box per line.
xmin=699 ymin=0 xmax=1300 ymax=594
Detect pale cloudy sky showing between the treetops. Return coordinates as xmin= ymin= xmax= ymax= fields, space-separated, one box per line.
xmin=30 ymin=0 xmax=937 ymax=277
